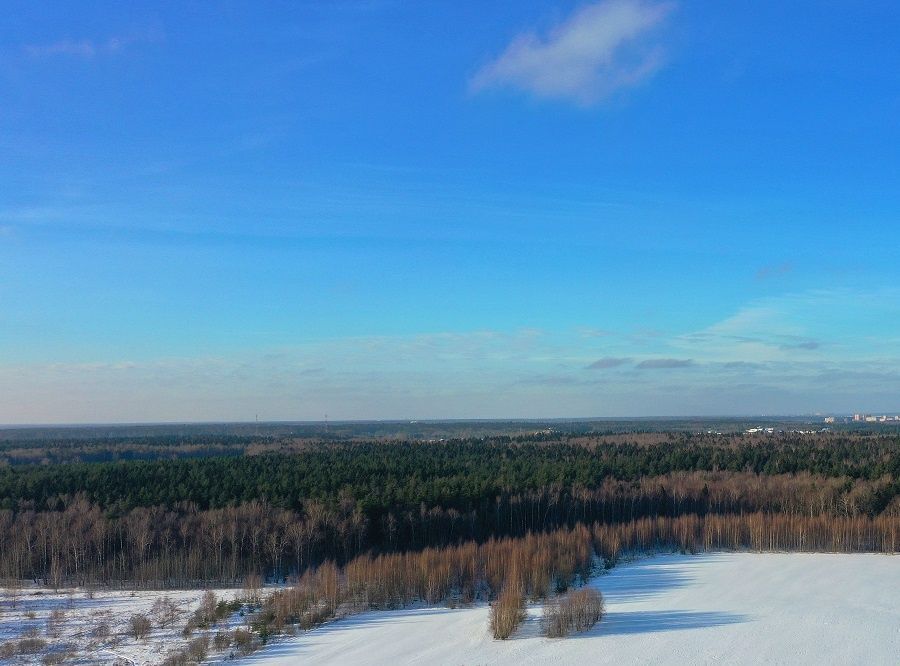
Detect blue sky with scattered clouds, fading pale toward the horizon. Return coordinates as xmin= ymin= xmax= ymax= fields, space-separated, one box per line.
xmin=0 ymin=0 xmax=900 ymax=423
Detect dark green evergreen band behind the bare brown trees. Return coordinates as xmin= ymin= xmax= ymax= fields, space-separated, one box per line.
xmin=0 ymin=435 xmax=900 ymax=510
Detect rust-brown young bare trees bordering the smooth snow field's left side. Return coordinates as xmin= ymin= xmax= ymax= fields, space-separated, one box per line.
xmin=251 ymin=526 xmax=594 ymax=639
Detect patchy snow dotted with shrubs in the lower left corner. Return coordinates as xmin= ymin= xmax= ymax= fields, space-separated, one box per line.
xmin=0 ymin=587 xmax=242 ymax=665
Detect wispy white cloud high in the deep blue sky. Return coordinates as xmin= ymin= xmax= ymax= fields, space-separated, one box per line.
xmin=470 ymin=0 xmax=674 ymax=106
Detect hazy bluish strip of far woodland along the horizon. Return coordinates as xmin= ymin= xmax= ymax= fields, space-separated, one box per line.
xmin=0 ymin=419 xmax=900 ymax=466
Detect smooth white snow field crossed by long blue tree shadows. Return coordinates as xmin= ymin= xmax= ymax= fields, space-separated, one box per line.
xmin=241 ymin=553 xmax=900 ymax=666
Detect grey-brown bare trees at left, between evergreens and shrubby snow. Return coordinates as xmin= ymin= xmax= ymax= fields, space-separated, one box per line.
xmin=0 ymin=498 xmax=367 ymax=586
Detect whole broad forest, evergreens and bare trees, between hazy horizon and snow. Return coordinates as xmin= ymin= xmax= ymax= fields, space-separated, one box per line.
xmin=0 ymin=433 xmax=900 ymax=585
